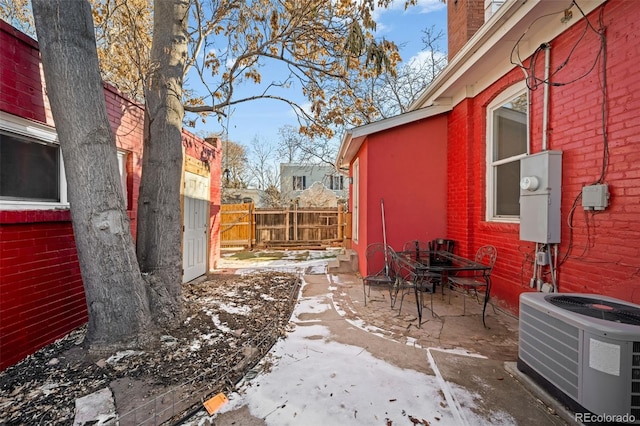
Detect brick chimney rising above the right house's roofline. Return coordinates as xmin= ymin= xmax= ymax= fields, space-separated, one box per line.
xmin=447 ymin=0 xmax=484 ymax=61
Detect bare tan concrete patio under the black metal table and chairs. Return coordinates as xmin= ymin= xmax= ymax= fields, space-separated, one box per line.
xmin=322 ymin=274 xmax=577 ymax=426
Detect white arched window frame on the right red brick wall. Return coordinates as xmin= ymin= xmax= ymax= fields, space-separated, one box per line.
xmin=486 ymin=81 xmax=531 ymax=223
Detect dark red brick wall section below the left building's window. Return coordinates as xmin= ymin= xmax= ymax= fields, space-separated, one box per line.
xmin=0 ymin=211 xmax=87 ymax=369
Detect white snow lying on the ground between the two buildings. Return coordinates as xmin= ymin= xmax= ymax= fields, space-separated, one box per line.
xmin=189 ymin=250 xmax=513 ymax=426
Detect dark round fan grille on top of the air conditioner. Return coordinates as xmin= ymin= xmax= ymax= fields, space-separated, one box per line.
xmin=545 ymin=295 xmax=640 ymax=325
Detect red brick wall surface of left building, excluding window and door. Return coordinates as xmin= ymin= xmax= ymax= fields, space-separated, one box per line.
xmin=0 ymin=21 xmax=221 ymax=370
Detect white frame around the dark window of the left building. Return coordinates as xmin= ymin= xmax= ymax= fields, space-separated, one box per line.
xmin=0 ymin=111 xmax=69 ymax=210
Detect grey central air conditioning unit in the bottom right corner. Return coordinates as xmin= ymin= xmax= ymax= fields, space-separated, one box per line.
xmin=518 ymin=293 xmax=640 ymax=424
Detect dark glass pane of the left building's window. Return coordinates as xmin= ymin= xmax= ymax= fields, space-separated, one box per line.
xmin=0 ymin=134 xmax=60 ymax=201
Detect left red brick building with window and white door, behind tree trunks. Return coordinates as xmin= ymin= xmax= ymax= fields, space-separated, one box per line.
xmin=0 ymin=21 xmax=221 ymax=370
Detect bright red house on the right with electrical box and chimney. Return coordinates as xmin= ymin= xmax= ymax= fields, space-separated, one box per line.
xmin=336 ymin=0 xmax=640 ymax=311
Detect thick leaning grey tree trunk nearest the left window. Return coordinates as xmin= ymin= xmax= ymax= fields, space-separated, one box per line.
xmin=32 ymin=0 xmax=150 ymax=348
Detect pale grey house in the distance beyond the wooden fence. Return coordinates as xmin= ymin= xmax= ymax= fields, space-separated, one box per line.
xmin=280 ymin=163 xmax=349 ymax=202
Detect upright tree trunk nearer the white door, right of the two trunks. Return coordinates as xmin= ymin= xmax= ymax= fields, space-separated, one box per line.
xmin=137 ymin=0 xmax=189 ymax=324
